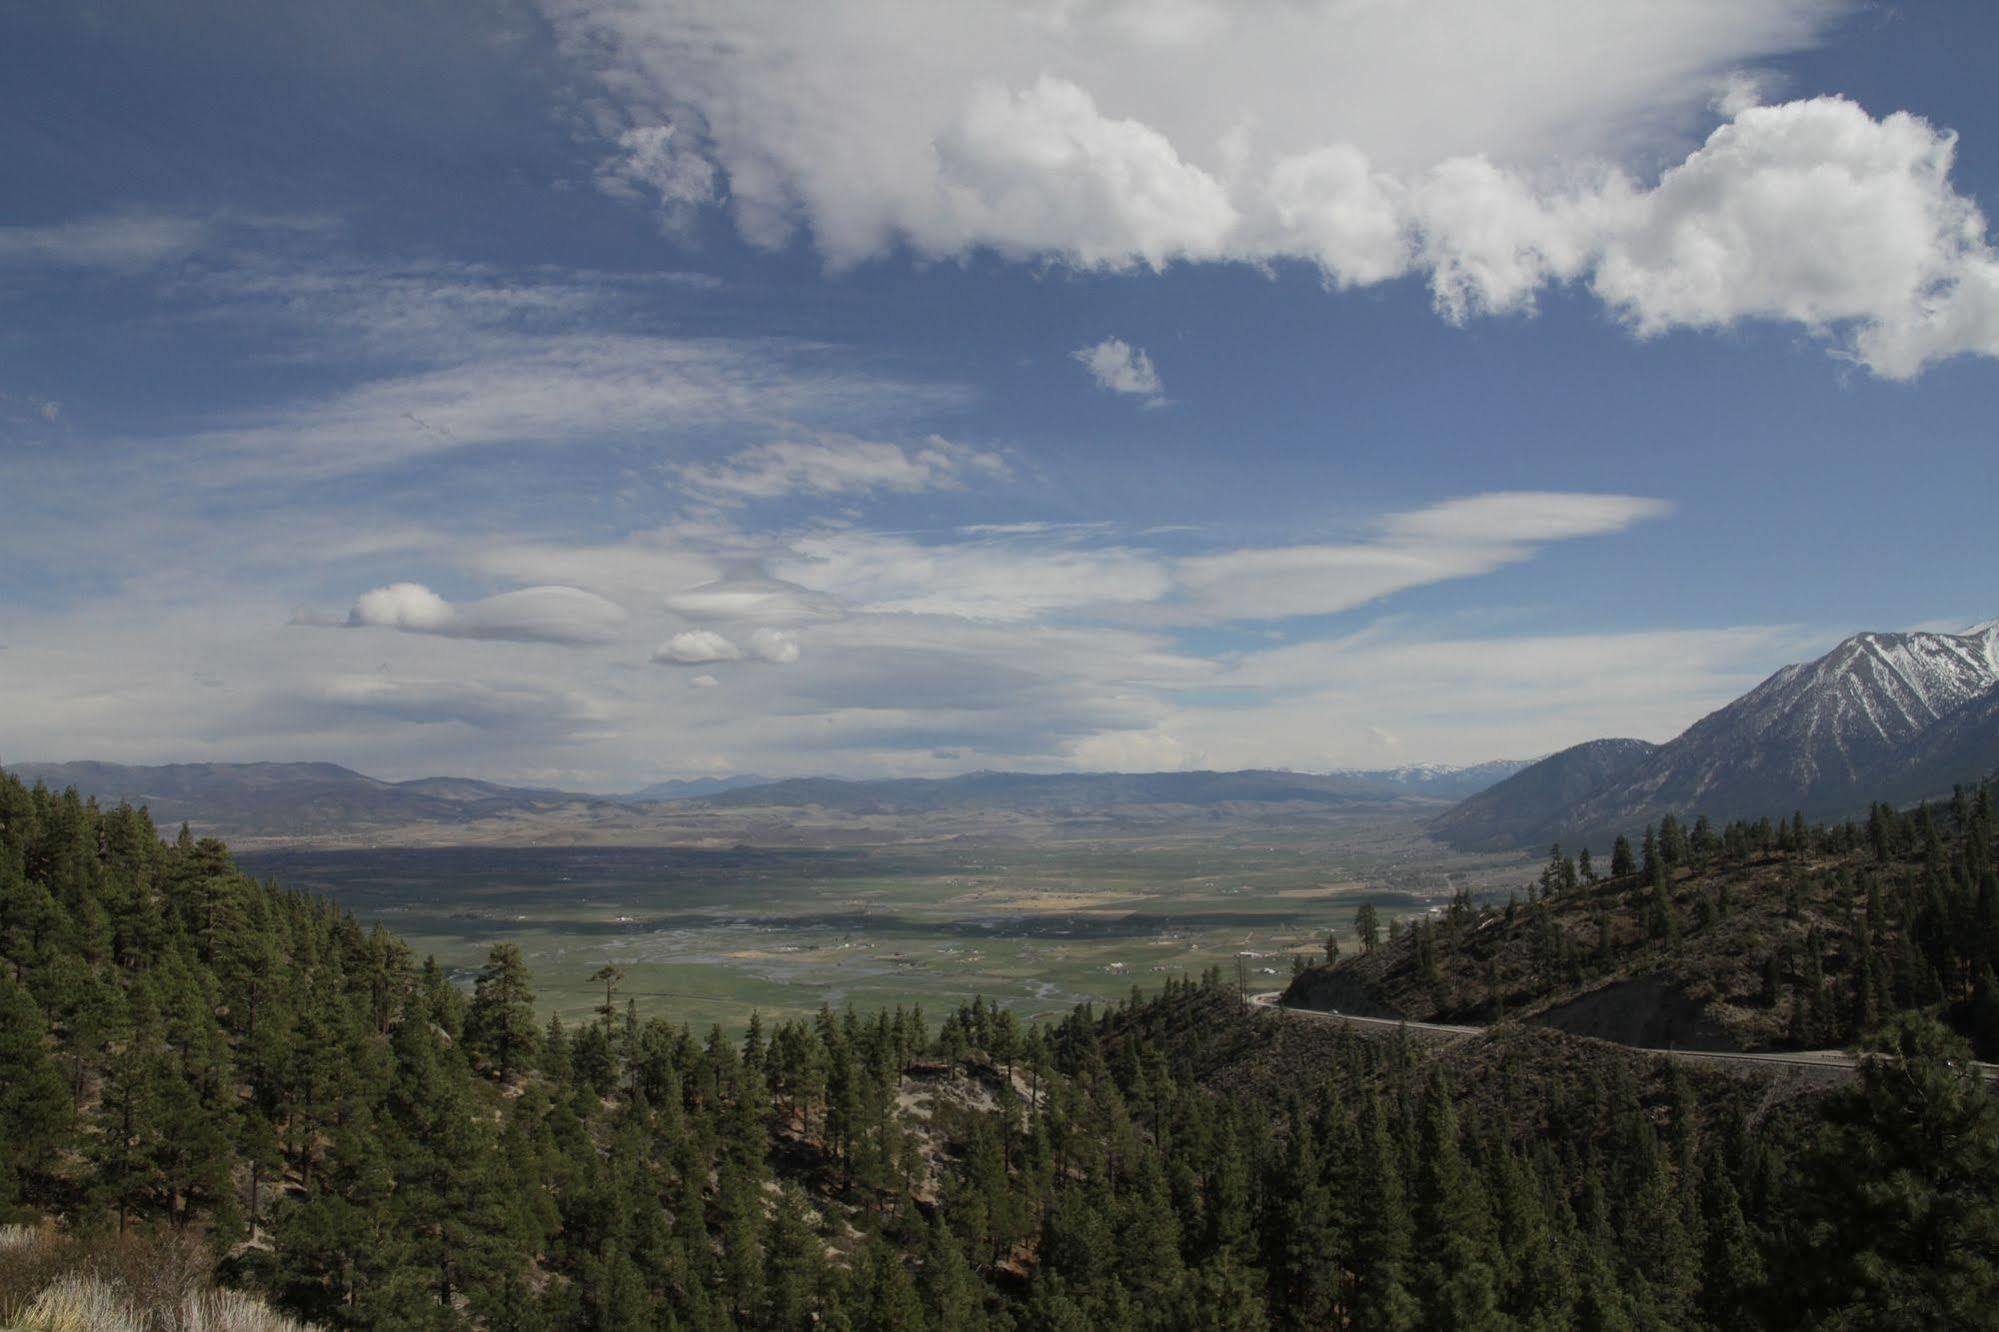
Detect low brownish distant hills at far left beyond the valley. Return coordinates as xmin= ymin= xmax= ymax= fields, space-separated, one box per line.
xmin=6 ymin=762 xmax=616 ymax=838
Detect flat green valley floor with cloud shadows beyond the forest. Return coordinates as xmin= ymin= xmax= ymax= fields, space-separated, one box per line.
xmin=242 ymin=820 xmax=1527 ymax=1030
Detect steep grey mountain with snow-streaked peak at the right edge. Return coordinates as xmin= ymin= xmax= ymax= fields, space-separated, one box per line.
xmin=1431 ymin=620 xmax=1999 ymax=850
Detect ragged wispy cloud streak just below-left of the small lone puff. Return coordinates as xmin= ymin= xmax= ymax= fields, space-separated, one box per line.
xmin=678 ymin=434 xmax=1007 ymax=502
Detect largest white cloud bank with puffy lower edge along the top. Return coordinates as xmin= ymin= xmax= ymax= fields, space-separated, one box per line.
xmin=544 ymin=0 xmax=1999 ymax=378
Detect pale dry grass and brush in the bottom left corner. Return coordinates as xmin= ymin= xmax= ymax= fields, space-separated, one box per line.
xmin=0 ymin=1226 xmax=310 ymax=1332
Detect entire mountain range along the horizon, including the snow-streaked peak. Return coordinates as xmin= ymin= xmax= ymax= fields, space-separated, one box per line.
xmin=23 ymin=620 xmax=1999 ymax=850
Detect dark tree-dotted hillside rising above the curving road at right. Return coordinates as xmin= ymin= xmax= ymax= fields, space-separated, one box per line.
xmin=1291 ymin=788 xmax=1999 ymax=1058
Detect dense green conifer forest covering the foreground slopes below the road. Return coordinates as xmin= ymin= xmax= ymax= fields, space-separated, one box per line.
xmin=0 ymin=764 xmax=1999 ymax=1328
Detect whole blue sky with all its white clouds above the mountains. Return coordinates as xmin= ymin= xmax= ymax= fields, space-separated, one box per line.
xmin=0 ymin=0 xmax=1999 ymax=790
